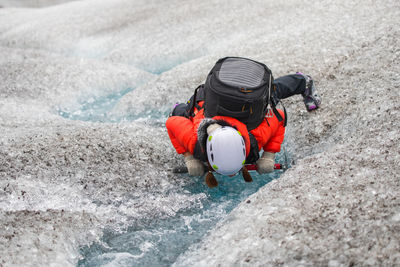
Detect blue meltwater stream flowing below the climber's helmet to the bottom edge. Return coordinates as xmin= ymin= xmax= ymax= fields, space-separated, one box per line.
xmin=78 ymin=166 xmax=283 ymax=266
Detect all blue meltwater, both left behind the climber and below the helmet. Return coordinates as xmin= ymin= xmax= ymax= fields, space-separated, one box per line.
xmin=58 ymin=88 xmax=287 ymax=266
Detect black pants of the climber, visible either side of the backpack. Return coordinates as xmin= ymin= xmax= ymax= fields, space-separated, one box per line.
xmin=170 ymin=74 xmax=306 ymax=118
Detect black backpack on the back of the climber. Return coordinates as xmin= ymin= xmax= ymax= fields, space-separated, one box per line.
xmin=188 ymin=57 xmax=286 ymax=131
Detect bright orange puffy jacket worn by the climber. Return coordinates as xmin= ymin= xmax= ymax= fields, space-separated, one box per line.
xmin=166 ymin=102 xmax=285 ymax=156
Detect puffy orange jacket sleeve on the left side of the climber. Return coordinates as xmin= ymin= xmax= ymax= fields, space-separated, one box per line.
xmin=165 ymin=116 xmax=197 ymax=154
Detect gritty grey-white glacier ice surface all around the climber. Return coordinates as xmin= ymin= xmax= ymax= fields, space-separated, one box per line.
xmin=0 ymin=0 xmax=400 ymax=266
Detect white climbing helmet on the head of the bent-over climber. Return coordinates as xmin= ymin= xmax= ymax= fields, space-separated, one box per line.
xmin=207 ymin=126 xmax=246 ymax=175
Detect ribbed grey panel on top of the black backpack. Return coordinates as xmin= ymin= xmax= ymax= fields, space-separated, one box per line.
xmin=219 ymin=58 xmax=265 ymax=87
